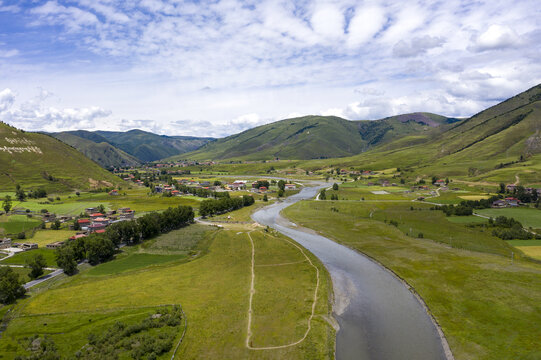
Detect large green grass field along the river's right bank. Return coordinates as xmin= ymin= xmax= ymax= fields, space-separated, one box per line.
xmin=284 ymin=201 xmax=541 ymax=360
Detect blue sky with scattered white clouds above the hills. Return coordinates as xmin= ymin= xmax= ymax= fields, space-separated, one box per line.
xmin=0 ymin=0 xmax=541 ymax=137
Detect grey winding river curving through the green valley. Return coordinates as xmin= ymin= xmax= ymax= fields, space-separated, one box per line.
xmin=252 ymin=185 xmax=446 ymax=360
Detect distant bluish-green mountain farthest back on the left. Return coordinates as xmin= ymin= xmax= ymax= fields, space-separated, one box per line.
xmin=94 ymin=130 xmax=212 ymax=162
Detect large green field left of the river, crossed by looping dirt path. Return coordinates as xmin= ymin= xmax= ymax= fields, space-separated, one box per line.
xmin=0 ymin=225 xmax=335 ymax=359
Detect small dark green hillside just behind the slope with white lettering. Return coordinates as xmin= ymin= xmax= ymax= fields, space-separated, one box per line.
xmin=52 ymin=130 xmax=141 ymax=168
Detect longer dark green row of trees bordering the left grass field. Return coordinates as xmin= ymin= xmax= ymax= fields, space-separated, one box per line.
xmin=56 ymin=206 xmax=194 ymax=275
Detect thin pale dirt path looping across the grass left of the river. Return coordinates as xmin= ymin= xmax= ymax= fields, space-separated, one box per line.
xmin=246 ymin=232 xmax=319 ymax=350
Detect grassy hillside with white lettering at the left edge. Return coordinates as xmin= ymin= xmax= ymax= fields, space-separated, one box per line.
xmin=0 ymin=123 xmax=120 ymax=191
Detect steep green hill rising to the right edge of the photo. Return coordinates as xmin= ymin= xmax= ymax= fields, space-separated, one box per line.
xmin=306 ymin=85 xmax=541 ymax=184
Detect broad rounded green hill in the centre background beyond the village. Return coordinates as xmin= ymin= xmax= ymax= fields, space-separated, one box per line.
xmin=179 ymin=113 xmax=459 ymax=160
